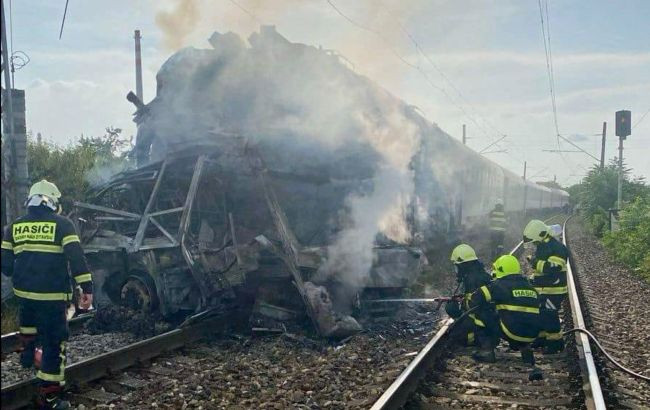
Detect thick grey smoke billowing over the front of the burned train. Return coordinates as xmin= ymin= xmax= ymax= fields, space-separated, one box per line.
xmin=136 ymin=27 xmax=422 ymax=286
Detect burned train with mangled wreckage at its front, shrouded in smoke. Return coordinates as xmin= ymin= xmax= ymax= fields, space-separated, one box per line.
xmin=67 ymin=26 xmax=565 ymax=337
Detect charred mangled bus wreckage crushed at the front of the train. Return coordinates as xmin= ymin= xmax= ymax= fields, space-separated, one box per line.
xmin=75 ymin=136 xmax=426 ymax=337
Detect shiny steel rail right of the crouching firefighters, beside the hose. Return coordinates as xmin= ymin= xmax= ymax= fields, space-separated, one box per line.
xmin=562 ymin=217 xmax=607 ymax=410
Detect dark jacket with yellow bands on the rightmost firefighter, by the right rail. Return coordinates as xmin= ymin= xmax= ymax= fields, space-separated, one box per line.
xmin=531 ymin=236 xmax=569 ymax=295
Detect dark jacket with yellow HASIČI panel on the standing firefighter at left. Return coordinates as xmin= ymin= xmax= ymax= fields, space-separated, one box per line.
xmin=2 ymin=206 xmax=92 ymax=301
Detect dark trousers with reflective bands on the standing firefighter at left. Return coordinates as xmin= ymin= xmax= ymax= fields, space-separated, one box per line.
xmin=18 ymin=297 xmax=68 ymax=386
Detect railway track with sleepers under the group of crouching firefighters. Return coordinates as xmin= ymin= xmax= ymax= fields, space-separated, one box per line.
xmin=372 ymin=216 xmax=606 ymax=410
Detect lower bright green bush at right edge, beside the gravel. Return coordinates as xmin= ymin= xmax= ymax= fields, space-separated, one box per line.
xmin=603 ymin=195 xmax=650 ymax=279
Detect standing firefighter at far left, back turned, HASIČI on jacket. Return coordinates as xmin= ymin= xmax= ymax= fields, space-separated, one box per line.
xmin=2 ymin=180 xmax=93 ymax=409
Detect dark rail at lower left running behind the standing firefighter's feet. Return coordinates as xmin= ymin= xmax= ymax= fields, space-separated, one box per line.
xmin=1 ymin=313 xmax=225 ymax=410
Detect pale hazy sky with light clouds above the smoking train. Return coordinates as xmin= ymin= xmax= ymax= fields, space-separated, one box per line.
xmin=4 ymin=0 xmax=650 ymax=186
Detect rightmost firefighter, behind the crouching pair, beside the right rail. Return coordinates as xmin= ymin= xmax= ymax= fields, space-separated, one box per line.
xmin=524 ymin=219 xmax=569 ymax=354
